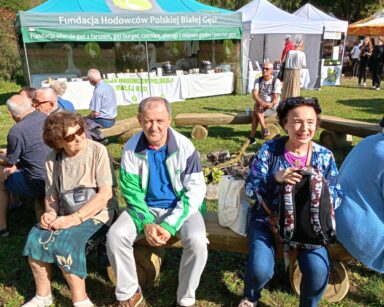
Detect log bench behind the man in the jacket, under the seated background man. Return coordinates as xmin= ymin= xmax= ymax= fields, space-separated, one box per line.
xmin=175 ymin=112 xmax=280 ymax=140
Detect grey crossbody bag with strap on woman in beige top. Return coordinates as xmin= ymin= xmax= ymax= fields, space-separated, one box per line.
xmin=56 ymin=152 xmax=97 ymax=215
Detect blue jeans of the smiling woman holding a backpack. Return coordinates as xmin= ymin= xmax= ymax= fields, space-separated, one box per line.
xmin=244 ymin=221 xmax=329 ymax=307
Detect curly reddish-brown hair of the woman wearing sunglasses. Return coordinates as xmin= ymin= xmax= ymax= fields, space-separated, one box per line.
xmin=43 ymin=111 xmax=86 ymax=151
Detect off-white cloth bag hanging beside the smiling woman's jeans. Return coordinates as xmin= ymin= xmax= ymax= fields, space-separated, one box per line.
xmin=218 ymin=176 xmax=249 ymax=236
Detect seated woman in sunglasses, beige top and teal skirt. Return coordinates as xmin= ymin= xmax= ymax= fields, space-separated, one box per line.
xmin=23 ymin=112 xmax=116 ymax=307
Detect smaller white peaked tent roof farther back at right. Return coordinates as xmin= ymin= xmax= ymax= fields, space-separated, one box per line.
xmin=293 ymin=3 xmax=348 ymax=33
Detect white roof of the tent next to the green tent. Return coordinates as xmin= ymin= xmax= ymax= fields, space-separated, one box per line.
xmin=238 ymin=0 xmax=323 ymax=34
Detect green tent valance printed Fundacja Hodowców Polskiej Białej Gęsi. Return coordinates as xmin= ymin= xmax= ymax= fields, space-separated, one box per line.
xmin=19 ymin=12 xmax=242 ymax=43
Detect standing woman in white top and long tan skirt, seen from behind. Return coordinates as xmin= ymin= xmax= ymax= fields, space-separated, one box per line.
xmin=281 ymin=39 xmax=307 ymax=100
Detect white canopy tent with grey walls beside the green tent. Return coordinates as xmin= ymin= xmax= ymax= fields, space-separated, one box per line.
xmin=238 ymin=0 xmax=323 ymax=88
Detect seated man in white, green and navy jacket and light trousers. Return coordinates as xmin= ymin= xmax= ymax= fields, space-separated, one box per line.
xmin=107 ymin=97 xmax=208 ymax=306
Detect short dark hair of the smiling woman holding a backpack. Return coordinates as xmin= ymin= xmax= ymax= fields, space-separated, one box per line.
xmin=276 ymin=96 xmax=322 ymax=129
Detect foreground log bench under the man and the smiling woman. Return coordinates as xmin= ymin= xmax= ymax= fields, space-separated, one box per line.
xmin=107 ymin=212 xmax=352 ymax=302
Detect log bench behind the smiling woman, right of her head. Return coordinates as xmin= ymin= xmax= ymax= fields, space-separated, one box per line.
xmin=320 ymin=115 xmax=382 ymax=149
